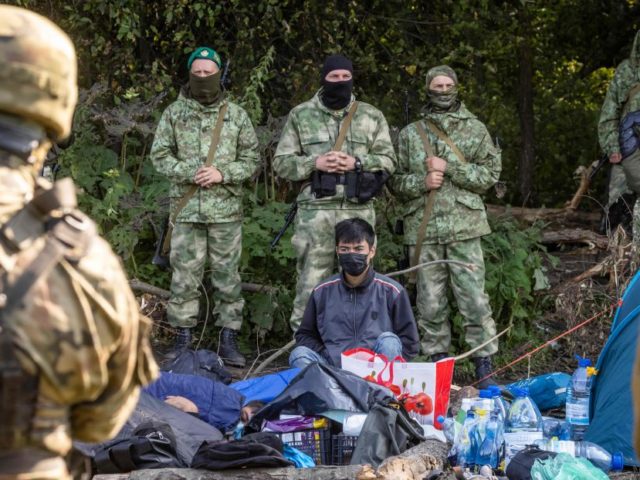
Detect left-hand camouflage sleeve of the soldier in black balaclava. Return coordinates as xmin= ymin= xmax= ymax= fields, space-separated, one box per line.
xmin=273 ymin=112 xmax=316 ymax=181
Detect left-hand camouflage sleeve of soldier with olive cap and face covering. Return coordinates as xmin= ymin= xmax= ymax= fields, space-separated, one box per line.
xmin=387 ymin=125 xmax=427 ymax=200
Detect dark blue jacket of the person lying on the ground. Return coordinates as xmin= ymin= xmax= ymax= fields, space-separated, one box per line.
xmin=144 ymin=372 xmax=244 ymax=432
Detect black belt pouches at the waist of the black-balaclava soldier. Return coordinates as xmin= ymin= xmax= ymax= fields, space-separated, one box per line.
xmin=311 ymin=170 xmax=389 ymax=203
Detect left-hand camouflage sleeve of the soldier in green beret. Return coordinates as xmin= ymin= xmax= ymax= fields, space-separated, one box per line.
xmin=150 ymin=107 xmax=198 ymax=183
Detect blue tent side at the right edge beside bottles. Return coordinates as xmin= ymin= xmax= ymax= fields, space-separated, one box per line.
xmin=585 ymin=272 xmax=640 ymax=466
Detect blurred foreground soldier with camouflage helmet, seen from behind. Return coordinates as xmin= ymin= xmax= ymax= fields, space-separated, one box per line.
xmin=0 ymin=5 xmax=157 ymax=480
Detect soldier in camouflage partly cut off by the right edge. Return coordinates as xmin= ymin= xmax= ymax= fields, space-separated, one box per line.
xmin=598 ymin=32 xmax=640 ymax=243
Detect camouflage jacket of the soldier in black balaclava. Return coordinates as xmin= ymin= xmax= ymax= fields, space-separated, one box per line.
xmin=273 ymin=92 xmax=396 ymax=209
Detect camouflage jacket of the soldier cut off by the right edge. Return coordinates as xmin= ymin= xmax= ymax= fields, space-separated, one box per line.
xmin=598 ymin=32 xmax=640 ymax=156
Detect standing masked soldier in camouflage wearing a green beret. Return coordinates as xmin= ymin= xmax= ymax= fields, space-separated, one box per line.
xmin=151 ymin=47 xmax=258 ymax=367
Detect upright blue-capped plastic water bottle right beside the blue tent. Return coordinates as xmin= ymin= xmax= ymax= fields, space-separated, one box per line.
xmin=566 ymin=357 xmax=593 ymax=441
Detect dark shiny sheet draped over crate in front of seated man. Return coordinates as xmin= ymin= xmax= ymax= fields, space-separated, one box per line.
xmin=247 ymin=363 xmax=393 ymax=431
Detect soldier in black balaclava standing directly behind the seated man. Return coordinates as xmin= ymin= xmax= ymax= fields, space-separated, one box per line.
xmin=273 ymin=55 xmax=396 ymax=331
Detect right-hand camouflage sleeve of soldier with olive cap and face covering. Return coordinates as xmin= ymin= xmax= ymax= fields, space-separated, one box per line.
xmin=445 ymin=124 xmax=502 ymax=194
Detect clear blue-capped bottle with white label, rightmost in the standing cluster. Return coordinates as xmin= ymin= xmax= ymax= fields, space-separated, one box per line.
xmin=504 ymin=387 xmax=542 ymax=464
